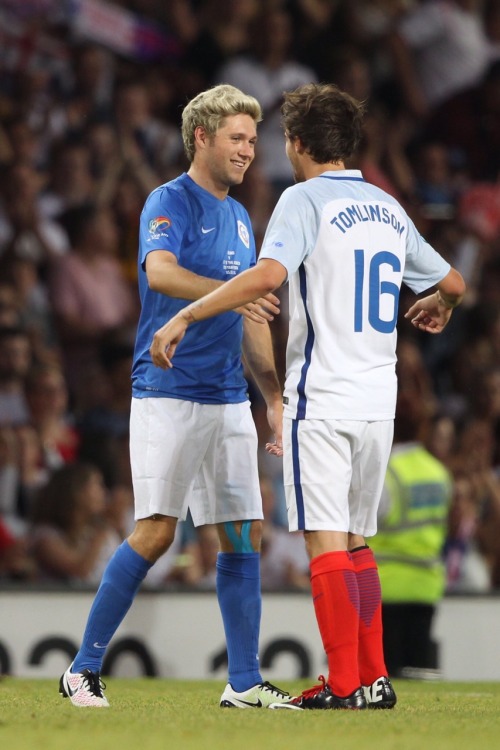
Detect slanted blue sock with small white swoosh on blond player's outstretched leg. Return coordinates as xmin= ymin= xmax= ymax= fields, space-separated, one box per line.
xmin=71 ymin=541 xmax=152 ymax=672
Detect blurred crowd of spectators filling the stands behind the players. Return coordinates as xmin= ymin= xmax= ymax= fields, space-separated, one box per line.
xmin=0 ymin=0 xmax=500 ymax=592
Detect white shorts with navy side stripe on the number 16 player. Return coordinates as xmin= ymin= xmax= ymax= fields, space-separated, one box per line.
xmin=283 ymin=417 xmax=394 ymax=537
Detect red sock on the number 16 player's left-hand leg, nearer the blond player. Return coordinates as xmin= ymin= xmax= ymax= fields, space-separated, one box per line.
xmin=311 ymin=552 xmax=361 ymax=697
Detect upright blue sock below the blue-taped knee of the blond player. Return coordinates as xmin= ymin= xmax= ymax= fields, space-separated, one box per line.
xmin=216 ymin=552 xmax=262 ymax=693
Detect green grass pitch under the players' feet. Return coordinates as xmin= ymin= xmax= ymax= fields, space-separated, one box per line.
xmin=0 ymin=677 xmax=500 ymax=750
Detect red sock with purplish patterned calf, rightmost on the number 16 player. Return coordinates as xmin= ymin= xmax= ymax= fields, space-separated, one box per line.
xmin=352 ymin=547 xmax=387 ymax=685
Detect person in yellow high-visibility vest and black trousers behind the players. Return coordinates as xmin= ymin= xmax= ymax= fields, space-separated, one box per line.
xmin=370 ymin=397 xmax=452 ymax=676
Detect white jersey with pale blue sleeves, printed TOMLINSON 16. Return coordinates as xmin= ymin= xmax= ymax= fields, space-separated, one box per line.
xmin=259 ymin=170 xmax=450 ymax=420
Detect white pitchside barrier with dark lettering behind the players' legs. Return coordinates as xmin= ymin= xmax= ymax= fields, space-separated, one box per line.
xmin=0 ymin=586 xmax=500 ymax=682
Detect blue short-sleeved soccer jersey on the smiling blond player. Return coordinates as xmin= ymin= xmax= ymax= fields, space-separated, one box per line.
xmin=132 ymin=174 xmax=256 ymax=404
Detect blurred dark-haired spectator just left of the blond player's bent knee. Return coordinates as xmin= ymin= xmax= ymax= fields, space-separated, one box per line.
xmin=31 ymin=463 xmax=120 ymax=585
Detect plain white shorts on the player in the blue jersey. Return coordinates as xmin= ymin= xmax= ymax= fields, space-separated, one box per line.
xmin=130 ymin=398 xmax=263 ymax=526
